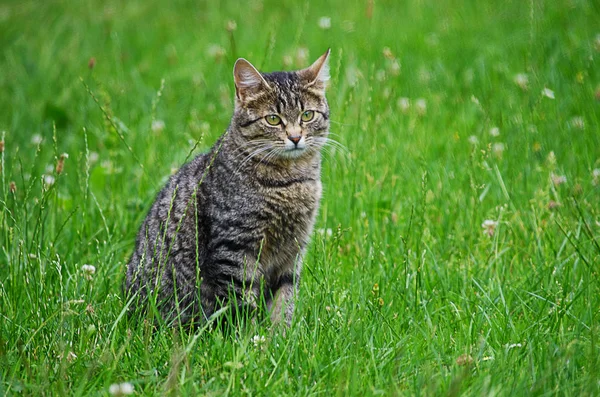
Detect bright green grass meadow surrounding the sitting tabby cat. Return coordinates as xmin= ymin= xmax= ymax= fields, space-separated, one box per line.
xmin=0 ymin=0 xmax=600 ymax=396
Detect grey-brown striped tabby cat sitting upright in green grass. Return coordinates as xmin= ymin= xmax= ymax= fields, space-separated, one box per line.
xmin=125 ymin=50 xmax=330 ymax=326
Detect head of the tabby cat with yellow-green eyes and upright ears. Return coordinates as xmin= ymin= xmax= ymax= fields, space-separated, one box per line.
xmin=232 ymin=50 xmax=330 ymax=159
